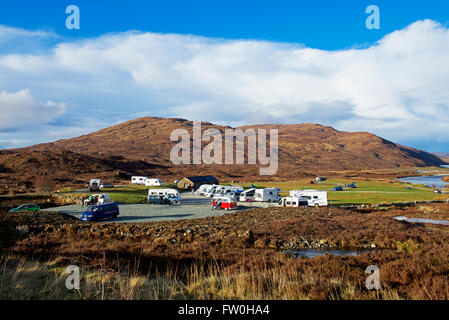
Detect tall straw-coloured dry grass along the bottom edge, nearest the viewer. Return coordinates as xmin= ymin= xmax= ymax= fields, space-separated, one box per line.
xmin=0 ymin=257 xmax=392 ymax=300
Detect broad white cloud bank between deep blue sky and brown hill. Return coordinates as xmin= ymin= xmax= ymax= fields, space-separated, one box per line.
xmin=0 ymin=20 xmax=449 ymax=150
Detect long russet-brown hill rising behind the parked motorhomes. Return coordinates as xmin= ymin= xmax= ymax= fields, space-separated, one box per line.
xmin=0 ymin=117 xmax=444 ymax=191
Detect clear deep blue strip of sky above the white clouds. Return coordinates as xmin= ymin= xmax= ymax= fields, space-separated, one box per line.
xmin=0 ymin=0 xmax=449 ymax=50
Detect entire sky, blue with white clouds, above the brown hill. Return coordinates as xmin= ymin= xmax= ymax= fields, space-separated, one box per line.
xmin=0 ymin=0 xmax=449 ymax=152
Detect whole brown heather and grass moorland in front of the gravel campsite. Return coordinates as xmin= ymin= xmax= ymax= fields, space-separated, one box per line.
xmin=0 ymin=204 xmax=449 ymax=300
